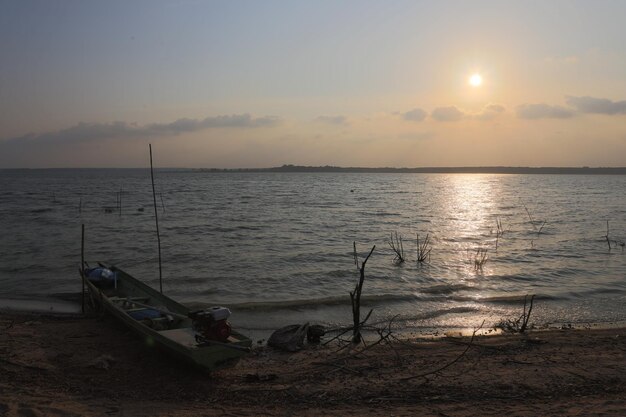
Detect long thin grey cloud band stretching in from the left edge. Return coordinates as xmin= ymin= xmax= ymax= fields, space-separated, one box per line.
xmin=0 ymin=114 xmax=280 ymax=144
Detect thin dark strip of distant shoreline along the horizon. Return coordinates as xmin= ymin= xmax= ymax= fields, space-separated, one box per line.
xmin=0 ymin=165 xmax=626 ymax=175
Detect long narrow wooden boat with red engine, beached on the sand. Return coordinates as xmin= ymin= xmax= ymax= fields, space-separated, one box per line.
xmin=81 ymin=264 xmax=252 ymax=371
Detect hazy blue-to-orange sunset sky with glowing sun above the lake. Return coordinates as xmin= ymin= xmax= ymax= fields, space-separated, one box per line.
xmin=0 ymin=0 xmax=626 ymax=168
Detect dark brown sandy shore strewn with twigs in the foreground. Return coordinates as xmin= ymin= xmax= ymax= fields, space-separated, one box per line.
xmin=0 ymin=312 xmax=626 ymax=417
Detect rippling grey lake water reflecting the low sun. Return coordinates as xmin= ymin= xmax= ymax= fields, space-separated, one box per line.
xmin=0 ymin=169 xmax=626 ymax=333
